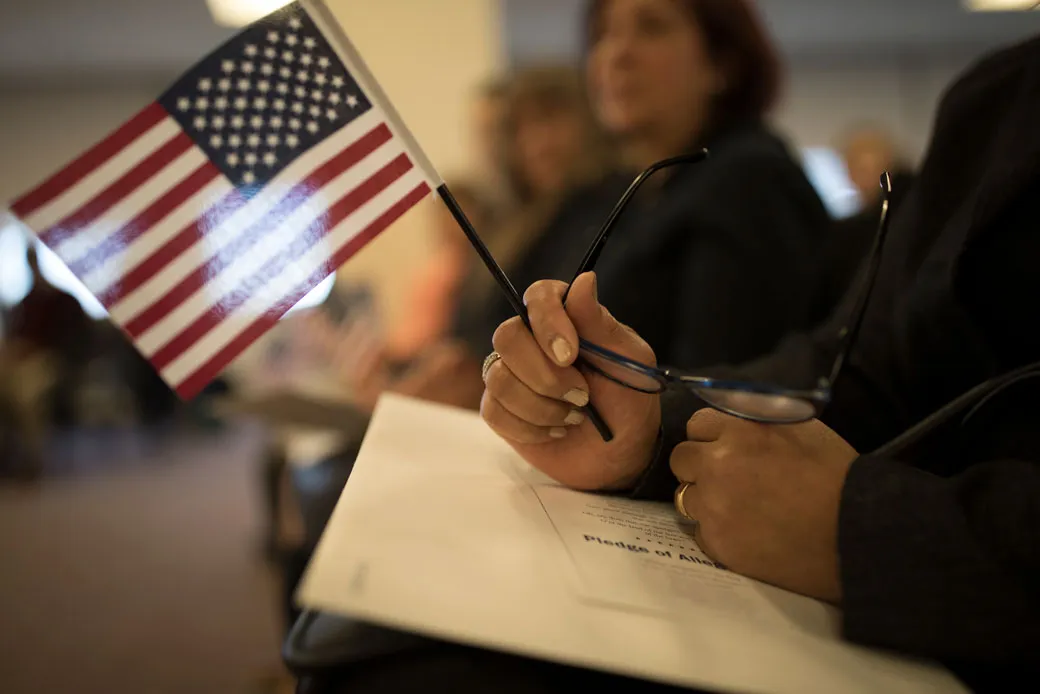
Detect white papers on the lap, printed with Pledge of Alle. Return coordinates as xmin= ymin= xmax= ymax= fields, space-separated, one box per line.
xmin=298 ymin=396 xmax=965 ymax=694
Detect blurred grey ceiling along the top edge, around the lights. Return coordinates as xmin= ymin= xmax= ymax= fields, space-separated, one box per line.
xmin=0 ymin=0 xmax=1040 ymax=83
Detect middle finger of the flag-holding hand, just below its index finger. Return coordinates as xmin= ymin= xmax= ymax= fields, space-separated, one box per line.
xmin=491 ymin=317 xmax=589 ymax=407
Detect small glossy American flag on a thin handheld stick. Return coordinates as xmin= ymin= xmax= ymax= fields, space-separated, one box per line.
xmin=11 ymin=2 xmax=440 ymax=399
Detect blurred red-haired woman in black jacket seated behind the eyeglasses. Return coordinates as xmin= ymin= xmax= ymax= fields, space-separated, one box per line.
xmin=485 ymin=0 xmax=829 ymax=374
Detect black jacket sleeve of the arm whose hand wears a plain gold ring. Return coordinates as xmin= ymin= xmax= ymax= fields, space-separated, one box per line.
xmin=838 ymin=457 xmax=1040 ymax=665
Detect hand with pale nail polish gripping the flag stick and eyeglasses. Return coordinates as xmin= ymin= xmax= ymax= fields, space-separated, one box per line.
xmin=480 ymin=273 xmax=660 ymax=490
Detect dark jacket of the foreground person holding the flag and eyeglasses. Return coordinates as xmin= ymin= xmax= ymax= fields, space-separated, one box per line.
xmin=639 ymin=38 xmax=1040 ymax=690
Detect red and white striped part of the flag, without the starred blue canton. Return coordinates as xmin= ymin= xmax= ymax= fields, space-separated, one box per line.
xmin=12 ymin=104 xmax=436 ymax=397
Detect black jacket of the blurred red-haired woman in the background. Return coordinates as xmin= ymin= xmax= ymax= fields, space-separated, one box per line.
xmin=455 ymin=124 xmax=830 ymax=365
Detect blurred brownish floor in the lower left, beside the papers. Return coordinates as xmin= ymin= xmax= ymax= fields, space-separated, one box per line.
xmin=0 ymin=420 xmax=281 ymax=694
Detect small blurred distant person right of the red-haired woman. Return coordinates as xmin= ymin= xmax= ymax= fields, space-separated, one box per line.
xmin=815 ymin=125 xmax=914 ymax=319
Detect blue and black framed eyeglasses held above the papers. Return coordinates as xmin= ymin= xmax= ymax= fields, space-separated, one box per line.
xmin=578 ymin=173 xmax=892 ymax=423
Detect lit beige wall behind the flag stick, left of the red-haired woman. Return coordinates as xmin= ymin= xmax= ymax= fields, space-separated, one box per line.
xmin=328 ymin=0 xmax=504 ymax=326
